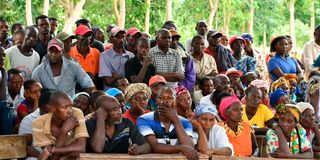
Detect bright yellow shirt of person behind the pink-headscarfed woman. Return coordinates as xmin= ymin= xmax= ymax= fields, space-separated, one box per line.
xmin=242 ymin=104 xmax=273 ymax=128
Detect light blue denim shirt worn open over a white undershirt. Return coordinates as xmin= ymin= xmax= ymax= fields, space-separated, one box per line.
xmin=32 ymin=57 xmax=94 ymax=97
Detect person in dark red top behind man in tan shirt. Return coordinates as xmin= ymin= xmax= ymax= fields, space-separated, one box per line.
xmin=16 ymin=79 xmax=42 ymax=128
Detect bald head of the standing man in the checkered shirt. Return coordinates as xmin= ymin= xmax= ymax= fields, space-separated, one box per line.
xmin=156 ymin=28 xmax=172 ymax=49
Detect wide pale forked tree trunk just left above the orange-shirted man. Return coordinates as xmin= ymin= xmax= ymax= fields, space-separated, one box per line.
xmin=62 ymin=0 xmax=86 ymax=34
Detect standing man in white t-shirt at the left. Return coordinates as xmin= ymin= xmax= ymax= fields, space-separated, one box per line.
xmin=5 ymin=26 xmax=40 ymax=79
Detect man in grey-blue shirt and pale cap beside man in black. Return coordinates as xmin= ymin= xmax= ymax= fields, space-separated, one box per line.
xmin=99 ymin=26 xmax=134 ymax=89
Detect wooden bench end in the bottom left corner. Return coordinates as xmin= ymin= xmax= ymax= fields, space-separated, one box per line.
xmin=0 ymin=135 xmax=27 ymax=159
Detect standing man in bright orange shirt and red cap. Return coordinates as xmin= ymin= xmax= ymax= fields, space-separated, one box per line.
xmin=70 ymin=25 xmax=100 ymax=85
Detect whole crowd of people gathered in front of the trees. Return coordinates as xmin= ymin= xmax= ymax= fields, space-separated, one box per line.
xmin=0 ymin=15 xmax=320 ymax=160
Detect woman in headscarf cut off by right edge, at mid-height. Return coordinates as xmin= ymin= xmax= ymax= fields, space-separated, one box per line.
xmin=307 ymin=76 xmax=320 ymax=122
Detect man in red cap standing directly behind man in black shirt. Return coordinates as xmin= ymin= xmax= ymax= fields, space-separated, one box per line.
xmin=126 ymin=27 xmax=141 ymax=55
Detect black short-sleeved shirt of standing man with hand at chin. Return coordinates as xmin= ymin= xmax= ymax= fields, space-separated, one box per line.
xmin=124 ymin=56 xmax=156 ymax=85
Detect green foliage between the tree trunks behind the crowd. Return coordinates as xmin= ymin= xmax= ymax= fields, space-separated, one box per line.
xmin=0 ymin=0 xmax=320 ymax=48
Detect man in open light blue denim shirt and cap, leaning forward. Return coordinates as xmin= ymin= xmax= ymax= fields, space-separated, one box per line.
xmin=31 ymin=39 xmax=94 ymax=97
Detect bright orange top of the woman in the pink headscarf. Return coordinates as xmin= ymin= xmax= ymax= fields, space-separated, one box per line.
xmin=220 ymin=121 xmax=253 ymax=157
